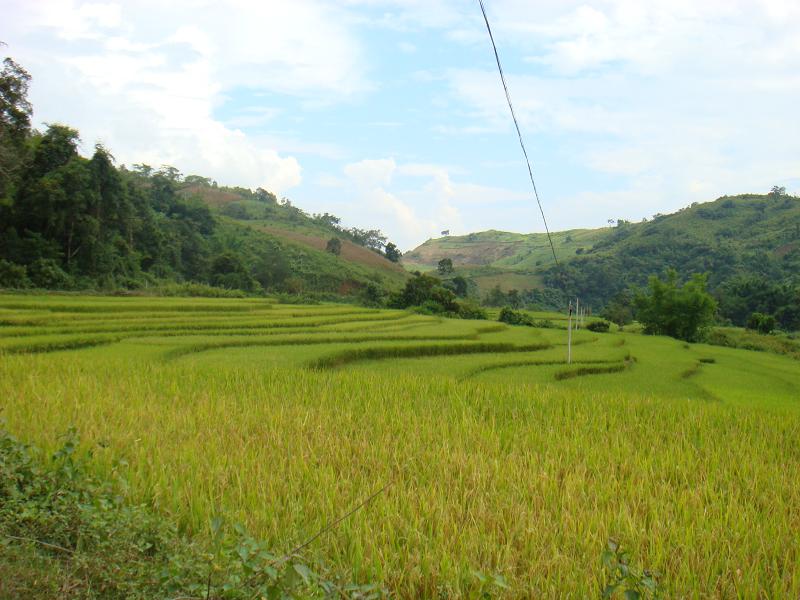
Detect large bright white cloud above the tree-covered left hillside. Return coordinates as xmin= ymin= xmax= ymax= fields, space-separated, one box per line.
xmin=2 ymin=0 xmax=369 ymax=192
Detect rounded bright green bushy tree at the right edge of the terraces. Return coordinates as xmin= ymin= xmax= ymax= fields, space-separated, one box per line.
xmin=634 ymin=269 xmax=717 ymax=342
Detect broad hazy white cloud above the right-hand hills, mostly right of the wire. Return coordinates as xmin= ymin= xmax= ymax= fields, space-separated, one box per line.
xmin=439 ymin=0 xmax=800 ymax=227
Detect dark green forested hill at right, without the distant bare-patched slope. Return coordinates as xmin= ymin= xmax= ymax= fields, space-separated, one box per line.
xmin=543 ymin=190 xmax=800 ymax=302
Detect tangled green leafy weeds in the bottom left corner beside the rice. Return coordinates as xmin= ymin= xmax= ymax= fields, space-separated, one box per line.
xmin=0 ymin=428 xmax=386 ymax=600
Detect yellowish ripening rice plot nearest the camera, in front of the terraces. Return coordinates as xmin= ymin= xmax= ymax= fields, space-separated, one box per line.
xmin=0 ymin=355 xmax=800 ymax=597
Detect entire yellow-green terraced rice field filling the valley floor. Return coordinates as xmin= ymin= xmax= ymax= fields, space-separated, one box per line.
xmin=0 ymin=296 xmax=800 ymax=598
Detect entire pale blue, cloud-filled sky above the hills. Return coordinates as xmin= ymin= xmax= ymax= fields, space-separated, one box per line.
xmin=0 ymin=0 xmax=800 ymax=250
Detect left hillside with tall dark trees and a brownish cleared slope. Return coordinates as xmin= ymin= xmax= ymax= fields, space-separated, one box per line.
xmin=0 ymin=59 xmax=407 ymax=301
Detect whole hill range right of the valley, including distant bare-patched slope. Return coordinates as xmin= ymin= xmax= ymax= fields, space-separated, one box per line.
xmin=403 ymin=195 xmax=800 ymax=328
